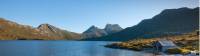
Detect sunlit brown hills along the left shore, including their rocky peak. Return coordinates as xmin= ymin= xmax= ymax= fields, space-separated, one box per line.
xmin=0 ymin=18 xmax=80 ymax=40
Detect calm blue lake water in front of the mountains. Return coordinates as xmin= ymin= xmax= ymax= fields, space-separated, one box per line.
xmin=0 ymin=40 xmax=152 ymax=56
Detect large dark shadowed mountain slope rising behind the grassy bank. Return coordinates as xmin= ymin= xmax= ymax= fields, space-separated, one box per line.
xmin=86 ymin=7 xmax=199 ymax=41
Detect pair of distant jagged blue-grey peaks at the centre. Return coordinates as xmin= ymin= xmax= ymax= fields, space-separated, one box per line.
xmin=82 ymin=24 xmax=122 ymax=39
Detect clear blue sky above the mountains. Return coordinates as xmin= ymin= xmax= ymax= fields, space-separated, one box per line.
xmin=0 ymin=0 xmax=199 ymax=33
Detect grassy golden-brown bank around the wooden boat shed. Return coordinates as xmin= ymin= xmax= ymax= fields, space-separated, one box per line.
xmin=106 ymin=32 xmax=199 ymax=53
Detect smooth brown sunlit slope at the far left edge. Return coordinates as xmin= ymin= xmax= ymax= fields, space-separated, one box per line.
xmin=0 ymin=18 xmax=48 ymax=40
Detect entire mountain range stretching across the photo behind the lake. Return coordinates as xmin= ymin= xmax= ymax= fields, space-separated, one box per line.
xmin=0 ymin=7 xmax=199 ymax=41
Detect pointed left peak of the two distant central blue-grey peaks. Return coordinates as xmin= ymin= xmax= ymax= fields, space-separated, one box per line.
xmin=82 ymin=26 xmax=107 ymax=38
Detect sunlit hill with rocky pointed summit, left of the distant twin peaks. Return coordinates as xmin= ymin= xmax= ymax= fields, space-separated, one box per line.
xmin=37 ymin=24 xmax=81 ymax=40
